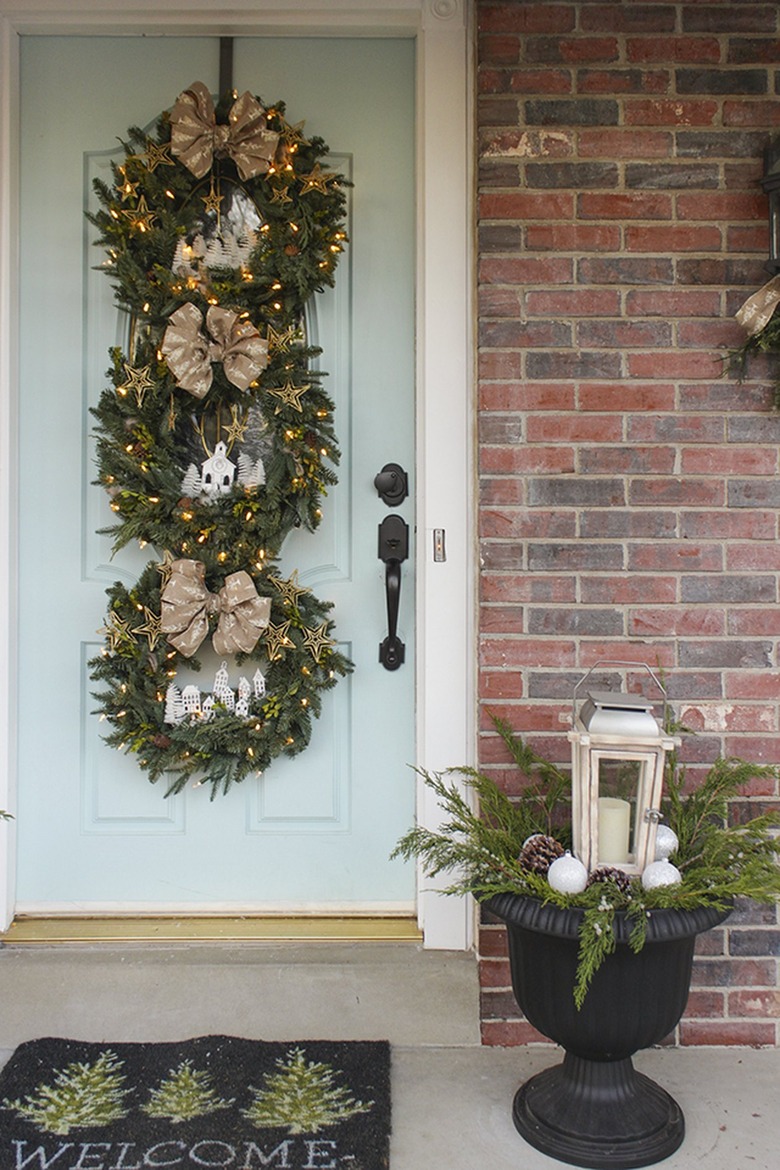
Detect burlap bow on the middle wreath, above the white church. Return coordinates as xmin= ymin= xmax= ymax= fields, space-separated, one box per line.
xmin=160 ymin=301 xmax=268 ymax=398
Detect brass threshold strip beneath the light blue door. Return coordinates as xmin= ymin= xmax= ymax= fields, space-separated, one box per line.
xmin=0 ymin=915 xmax=422 ymax=947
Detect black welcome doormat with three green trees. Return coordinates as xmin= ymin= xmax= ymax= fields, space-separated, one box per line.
xmin=0 ymin=1035 xmax=391 ymax=1170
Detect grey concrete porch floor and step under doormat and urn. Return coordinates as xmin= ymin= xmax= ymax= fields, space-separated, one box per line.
xmin=0 ymin=943 xmax=780 ymax=1170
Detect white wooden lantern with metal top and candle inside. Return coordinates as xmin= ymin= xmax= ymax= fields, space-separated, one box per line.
xmin=568 ymin=662 xmax=681 ymax=874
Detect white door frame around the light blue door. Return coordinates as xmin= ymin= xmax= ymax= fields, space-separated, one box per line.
xmin=0 ymin=0 xmax=476 ymax=949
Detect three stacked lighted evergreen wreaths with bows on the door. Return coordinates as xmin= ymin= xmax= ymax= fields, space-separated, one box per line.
xmin=89 ymin=82 xmax=351 ymax=797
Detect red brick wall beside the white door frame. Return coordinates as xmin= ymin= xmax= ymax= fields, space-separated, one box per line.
xmin=476 ymin=0 xmax=780 ymax=1044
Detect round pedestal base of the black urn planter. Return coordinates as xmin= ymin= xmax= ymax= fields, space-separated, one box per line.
xmin=512 ymin=1052 xmax=685 ymax=1170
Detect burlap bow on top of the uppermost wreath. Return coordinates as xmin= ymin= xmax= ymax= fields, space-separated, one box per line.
xmin=171 ymin=81 xmax=279 ymax=181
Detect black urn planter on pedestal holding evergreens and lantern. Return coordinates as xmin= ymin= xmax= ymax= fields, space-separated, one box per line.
xmin=485 ymin=894 xmax=730 ymax=1170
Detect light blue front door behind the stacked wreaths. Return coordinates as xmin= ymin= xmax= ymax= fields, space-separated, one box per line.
xmin=18 ymin=37 xmax=415 ymax=913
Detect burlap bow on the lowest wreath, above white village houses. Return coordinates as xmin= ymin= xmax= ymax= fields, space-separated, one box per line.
xmin=160 ymin=560 xmax=271 ymax=658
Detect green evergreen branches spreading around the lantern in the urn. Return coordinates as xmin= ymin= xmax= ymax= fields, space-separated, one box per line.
xmin=392 ymin=718 xmax=780 ymax=1007
